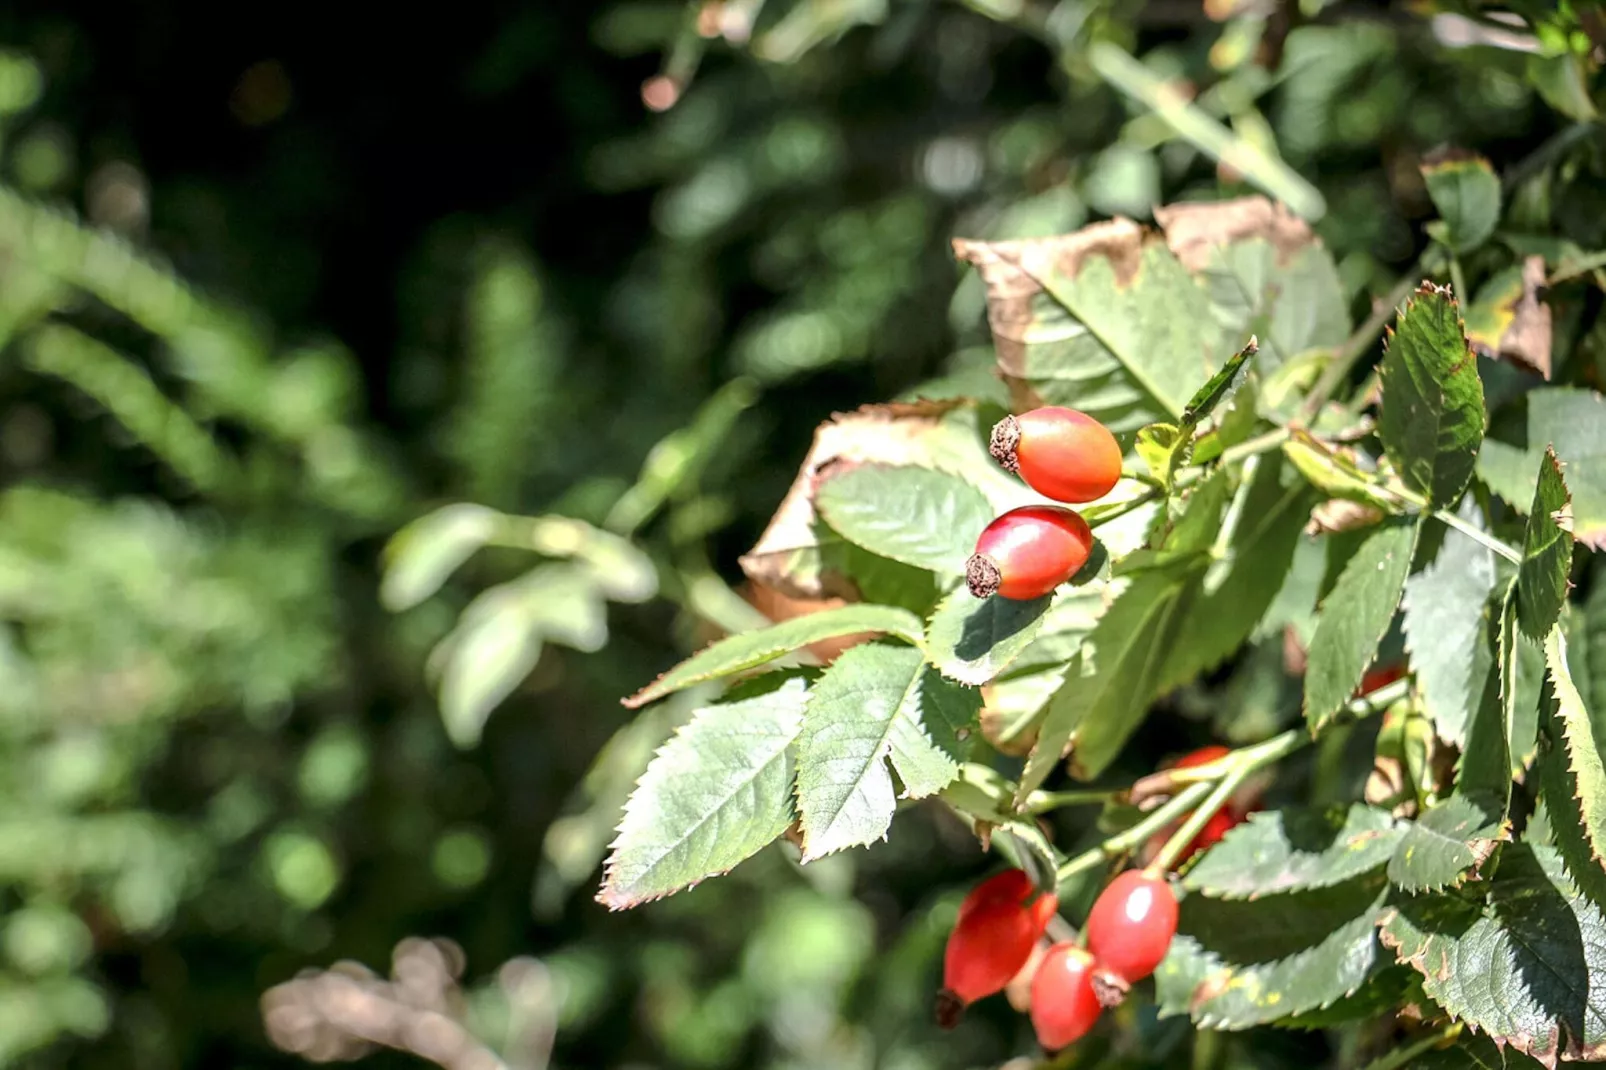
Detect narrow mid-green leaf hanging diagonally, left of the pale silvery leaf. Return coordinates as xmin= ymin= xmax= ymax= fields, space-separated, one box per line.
xmin=1304 ymin=519 xmax=1420 ymax=729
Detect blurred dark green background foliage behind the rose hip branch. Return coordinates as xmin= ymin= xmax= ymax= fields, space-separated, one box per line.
xmin=0 ymin=0 xmax=1606 ymax=1070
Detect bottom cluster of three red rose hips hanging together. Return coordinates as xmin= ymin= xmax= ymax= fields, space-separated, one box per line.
xmin=936 ymin=869 xmax=1177 ymax=1052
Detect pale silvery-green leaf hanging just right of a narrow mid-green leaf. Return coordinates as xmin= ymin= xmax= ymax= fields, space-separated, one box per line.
xmin=1402 ymin=506 xmax=1495 ymax=745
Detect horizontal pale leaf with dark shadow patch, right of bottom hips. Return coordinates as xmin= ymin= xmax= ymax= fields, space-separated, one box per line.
xmin=1182 ymin=803 xmax=1405 ymax=900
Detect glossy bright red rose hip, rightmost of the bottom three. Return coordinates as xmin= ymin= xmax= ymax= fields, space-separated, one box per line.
xmin=1087 ymin=869 xmax=1177 ymax=1007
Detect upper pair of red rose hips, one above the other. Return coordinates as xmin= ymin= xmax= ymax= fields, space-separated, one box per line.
xmin=965 ymin=405 xmax=1121 ymax=601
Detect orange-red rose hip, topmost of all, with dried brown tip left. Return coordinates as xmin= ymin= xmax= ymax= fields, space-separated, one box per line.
xmin=991 ymin=405 xmax=1121 ymax=501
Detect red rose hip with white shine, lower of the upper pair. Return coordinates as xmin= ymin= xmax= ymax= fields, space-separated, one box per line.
xmin=965 ymin=506 xmax=1094 ymax=601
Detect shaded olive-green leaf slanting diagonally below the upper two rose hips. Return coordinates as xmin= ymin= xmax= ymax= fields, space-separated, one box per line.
xmin=1015 ymin=569 xmax=1190 ymax=787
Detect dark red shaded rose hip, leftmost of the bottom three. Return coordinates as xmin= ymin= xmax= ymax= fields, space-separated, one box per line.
xmin=936 ymin=869 xmax=1060 ymax=1028
